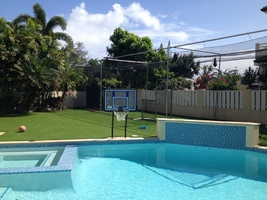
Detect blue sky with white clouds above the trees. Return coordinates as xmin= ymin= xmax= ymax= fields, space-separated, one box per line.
xmin=0 ymin=0 xmax=267 ymax=71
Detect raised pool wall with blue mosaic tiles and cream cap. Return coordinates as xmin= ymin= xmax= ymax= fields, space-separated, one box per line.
xmin=157 ymin=118 xmax=267 ymax=154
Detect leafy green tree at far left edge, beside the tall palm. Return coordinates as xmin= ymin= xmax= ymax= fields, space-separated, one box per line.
xmin=0 ymin=17 xmax=40 ymax=97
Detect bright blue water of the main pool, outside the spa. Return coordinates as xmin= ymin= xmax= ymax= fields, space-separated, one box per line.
xmin=0 ymin=143 xmax=267 ymax=200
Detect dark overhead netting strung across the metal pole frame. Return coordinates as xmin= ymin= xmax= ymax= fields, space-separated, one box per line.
xmin=81 ymin=30 xmax=267 ymax=73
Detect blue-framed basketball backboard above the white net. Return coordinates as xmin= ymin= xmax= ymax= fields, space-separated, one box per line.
xmin=105 ymin=89 xmax=136 ymax=111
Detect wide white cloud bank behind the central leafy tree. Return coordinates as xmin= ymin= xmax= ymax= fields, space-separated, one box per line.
xmin=65 ymin=3 xmax=218 ymax=59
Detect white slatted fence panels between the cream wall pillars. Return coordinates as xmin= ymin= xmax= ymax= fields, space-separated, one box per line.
xmin=142 ymin=90 xmax=267 ymax=111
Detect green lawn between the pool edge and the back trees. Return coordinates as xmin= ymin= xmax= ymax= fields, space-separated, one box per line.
xmin=0 ymin=109 xmax=163 ymax=142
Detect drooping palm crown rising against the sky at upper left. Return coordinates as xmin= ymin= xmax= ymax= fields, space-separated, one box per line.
xmin=13 ymin=3 xmax=73 ymax=47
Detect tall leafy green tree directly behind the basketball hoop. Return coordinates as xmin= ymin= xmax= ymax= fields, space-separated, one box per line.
xmin=105 ymin=27 xmax=165 ymax=88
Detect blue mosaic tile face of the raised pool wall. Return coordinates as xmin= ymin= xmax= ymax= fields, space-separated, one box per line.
xmin=168 ymin=122 xmax=246 ymax=149
